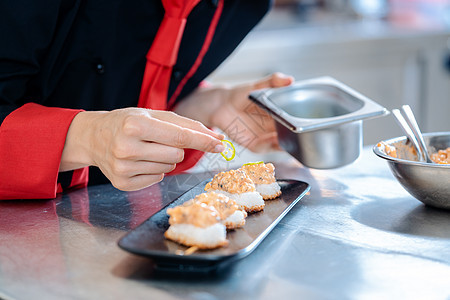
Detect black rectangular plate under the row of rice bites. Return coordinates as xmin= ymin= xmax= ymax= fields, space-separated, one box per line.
xmin=119 ymin=180 xmax=310 ymax=268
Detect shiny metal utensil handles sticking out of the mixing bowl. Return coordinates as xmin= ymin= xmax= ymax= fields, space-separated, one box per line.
xmin=392 ymin=105 xmax=433 ymax=163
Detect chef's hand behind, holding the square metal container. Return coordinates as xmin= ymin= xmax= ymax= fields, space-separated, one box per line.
xmin=175 ymin=73 xmax=294 ymax=152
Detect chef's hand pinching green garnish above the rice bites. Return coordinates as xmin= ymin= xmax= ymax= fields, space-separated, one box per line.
xmin=60 ymin=108 xmax=224 ymax=191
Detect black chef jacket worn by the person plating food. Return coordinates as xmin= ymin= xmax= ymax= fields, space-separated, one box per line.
xmin=0 ymin=0 xmax=271 ymax=183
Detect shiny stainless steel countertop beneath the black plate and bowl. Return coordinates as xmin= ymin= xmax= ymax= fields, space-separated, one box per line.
xmin=0 ymin=148 xmax=450 ymax=299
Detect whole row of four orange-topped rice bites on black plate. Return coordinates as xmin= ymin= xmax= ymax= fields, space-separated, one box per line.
xmin=164 ymin=162 xmax=281 ymax=249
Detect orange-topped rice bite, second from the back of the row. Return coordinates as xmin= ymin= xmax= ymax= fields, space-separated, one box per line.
xmin=205 ymin=170 xmax=265 ymax=213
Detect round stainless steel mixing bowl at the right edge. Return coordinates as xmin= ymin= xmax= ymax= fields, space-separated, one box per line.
xmin=373 ymin=132 xmax=450 ymax=209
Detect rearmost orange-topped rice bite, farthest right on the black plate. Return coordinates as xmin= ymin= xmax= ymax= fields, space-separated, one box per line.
xmin=241 ymin=162 xmax=281 ymax=200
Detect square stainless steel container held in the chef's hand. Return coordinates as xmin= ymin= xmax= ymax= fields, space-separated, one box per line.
xmin=250 ymin=77 xmax=388 ymax=169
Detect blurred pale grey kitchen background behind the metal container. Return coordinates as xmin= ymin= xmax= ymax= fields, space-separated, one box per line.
xmin=205 ymin=0 xmax=450 ymax=145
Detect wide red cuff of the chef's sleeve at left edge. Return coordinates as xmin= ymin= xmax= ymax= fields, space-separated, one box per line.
xmin=0 ymin=103 xmax=88 ymax=200
